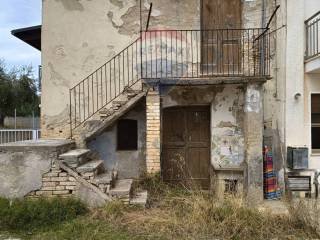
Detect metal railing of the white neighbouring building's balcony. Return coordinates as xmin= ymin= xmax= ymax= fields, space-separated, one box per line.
xmin=305 ymin=11 xmax=320 ymax=60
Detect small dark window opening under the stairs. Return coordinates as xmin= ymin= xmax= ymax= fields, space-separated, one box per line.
xmin=117 ymin=119 xmax=138 ymax=150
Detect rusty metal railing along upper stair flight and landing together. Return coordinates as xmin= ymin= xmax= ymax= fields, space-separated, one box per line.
xmin=70 ymin=28 xmax=271 ymax=134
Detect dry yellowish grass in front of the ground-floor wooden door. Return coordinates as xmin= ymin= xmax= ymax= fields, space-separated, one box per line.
xmin=90 ymin=174 xmax=319 ymax=240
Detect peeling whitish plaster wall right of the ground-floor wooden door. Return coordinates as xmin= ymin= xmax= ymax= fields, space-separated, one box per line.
xmin=211 ymin=86 xmax=244 ymax=169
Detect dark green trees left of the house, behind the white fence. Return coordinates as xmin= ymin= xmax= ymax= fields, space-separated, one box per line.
xmin=0 ymin=61 xmax=40 ymax=124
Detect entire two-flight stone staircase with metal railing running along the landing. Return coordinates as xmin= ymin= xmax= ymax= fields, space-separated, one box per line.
xmin=66 ymin=28 xmax=270 ymax=203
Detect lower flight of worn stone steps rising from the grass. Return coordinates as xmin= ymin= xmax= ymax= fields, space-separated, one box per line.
xmin=59 ymin=149 xmax=147 ymax=206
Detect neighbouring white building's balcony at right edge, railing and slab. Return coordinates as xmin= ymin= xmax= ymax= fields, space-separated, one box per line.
xmin=305 ymin=11 xmax=320 ymax=73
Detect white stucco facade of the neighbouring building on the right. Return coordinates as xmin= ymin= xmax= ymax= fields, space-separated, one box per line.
xmin=265 ymin=0 xmax=320 ymax=195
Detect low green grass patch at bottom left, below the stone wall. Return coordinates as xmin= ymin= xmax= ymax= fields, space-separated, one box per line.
xmin=0 ymin=198 xmax=87 ymax=231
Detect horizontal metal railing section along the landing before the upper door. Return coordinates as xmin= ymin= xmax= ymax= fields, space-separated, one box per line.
xmin=141 ymin=29 xmax=270 ymax=79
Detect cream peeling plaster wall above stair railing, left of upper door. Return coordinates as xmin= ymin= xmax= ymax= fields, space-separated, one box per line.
xmin=41 ymin=0 xmax=200 ymax=137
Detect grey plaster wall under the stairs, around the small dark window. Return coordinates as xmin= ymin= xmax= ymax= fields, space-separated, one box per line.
xmin=88 ymin=101 xmax=146 ymax=178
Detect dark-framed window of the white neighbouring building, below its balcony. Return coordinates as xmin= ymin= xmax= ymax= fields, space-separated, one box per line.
xmin=311 ymin=94 xmax=320 ymax=151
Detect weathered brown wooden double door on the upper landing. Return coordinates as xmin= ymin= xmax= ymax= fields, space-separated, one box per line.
xmin=201 ymin=0 xmax=243 ymax=75
